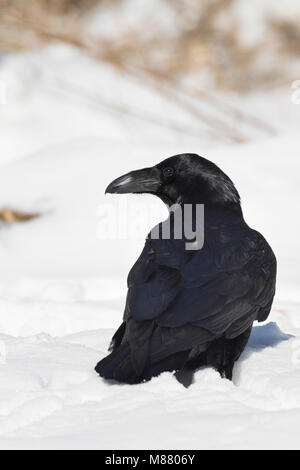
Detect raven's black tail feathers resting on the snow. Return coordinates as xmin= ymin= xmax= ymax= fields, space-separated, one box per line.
xmin=95 ymin=324 xmax=212 ymax=384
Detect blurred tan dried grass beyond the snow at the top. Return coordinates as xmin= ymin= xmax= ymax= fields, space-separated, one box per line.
xmin=0 ymin=0 xmax=300 ymax=142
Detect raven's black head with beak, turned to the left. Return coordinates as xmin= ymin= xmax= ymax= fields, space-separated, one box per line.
xmin=105 ymin=153 xmax=240 ymax=208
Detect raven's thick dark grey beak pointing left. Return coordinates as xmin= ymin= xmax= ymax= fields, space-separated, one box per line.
xmin=105 ymin=167 xmax=161 ymax=194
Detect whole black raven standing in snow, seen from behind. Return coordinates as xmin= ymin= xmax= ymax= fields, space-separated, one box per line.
xmin=96 ymin=153 xmax=276 ymax=386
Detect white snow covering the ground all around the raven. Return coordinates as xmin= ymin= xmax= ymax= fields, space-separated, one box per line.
xmin=0 ymin=47 xmax=300 ymax=449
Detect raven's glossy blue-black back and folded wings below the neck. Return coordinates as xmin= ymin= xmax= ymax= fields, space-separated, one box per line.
xmin=124 ymin=229 xmax=276 ymax=374
